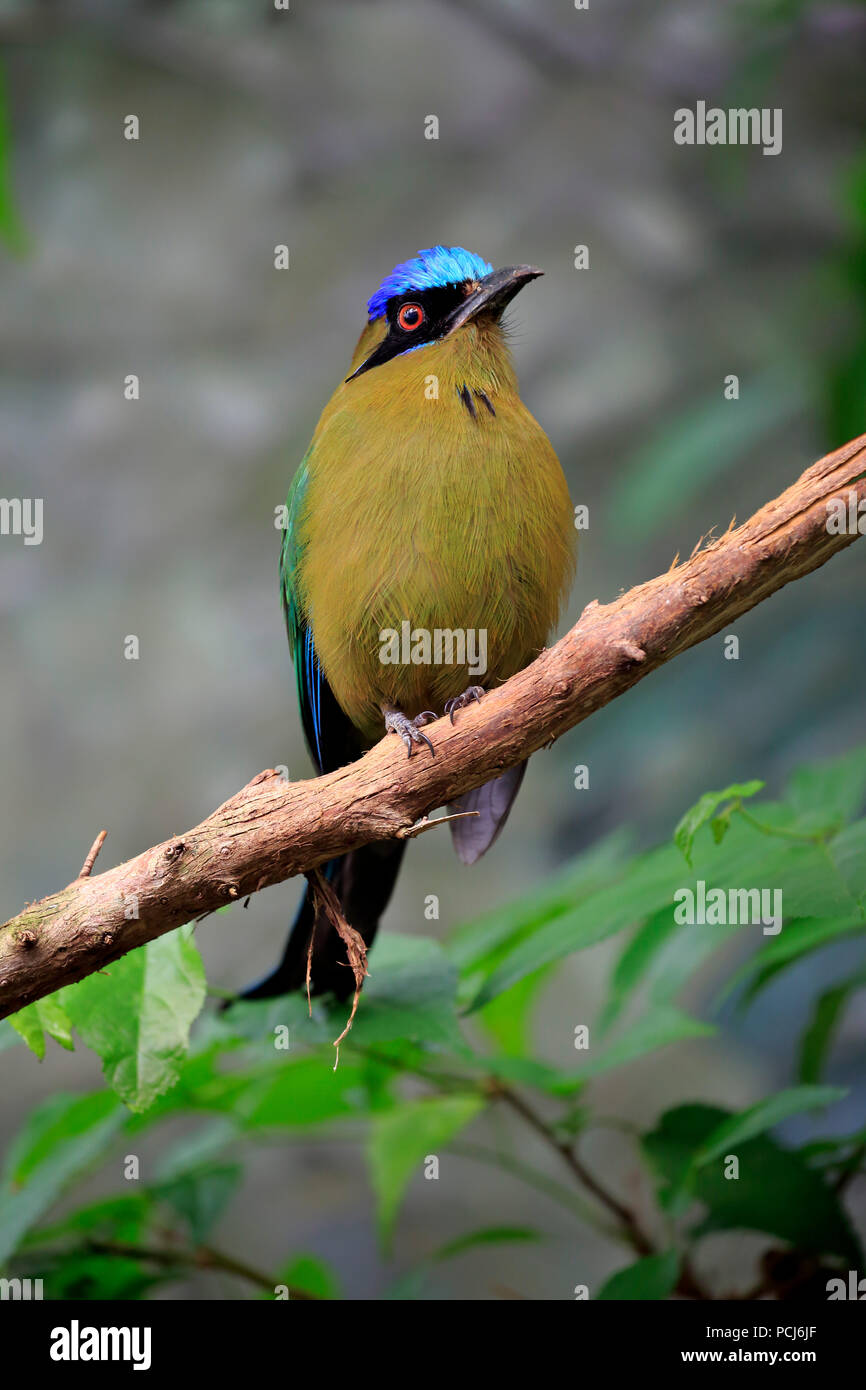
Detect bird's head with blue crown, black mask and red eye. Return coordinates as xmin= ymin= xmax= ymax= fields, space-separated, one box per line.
xmin=346 ymin=246 xmax=544 ymax=381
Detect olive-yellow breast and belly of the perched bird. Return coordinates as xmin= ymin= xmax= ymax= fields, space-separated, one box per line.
xmin=295 ymin=325 xmax=575 ymax=742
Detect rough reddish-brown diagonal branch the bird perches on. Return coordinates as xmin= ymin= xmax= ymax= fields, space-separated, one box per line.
xmin=0 ymin=435 xmax=866 ymax=1017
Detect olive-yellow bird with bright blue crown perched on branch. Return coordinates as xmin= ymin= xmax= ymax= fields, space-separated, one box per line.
xmin=242 ymin=245 xmax=577 ymax=999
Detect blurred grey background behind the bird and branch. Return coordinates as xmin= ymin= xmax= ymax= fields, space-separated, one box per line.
xmin=0 ymin=0 xmax=866 ymax=1298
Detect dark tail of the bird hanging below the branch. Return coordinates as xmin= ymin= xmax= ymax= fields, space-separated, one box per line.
xmin=240 ymin=840 xmax=406 ymax=999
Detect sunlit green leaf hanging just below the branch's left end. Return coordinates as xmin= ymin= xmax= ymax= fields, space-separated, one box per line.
xmin=63 ymin=930 xmax=206 ymax=1112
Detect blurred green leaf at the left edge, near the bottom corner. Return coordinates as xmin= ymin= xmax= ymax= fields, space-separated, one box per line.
xmin=0 ymin=1091 xmax=124 ymax=1266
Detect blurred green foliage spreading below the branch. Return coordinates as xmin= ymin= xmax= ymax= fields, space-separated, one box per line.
xmin=0 ymin=748 xmax=866 ymax=1298
